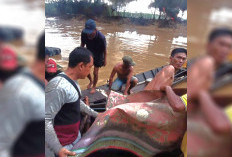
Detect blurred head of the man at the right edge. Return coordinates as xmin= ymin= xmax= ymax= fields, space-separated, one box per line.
xmin=207 ymin=28 xmax=232 ymax=65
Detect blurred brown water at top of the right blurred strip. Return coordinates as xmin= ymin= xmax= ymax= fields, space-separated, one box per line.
xmin=187 ymin=0 xmax=232 ymax=59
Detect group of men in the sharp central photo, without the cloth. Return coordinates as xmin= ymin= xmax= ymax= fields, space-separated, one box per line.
xmin=45 ymin=19 xmax=187 ymax=156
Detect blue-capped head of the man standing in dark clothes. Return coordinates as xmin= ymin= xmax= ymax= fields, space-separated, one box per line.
xmin=83 ymin=19 xmax=97 ymax=40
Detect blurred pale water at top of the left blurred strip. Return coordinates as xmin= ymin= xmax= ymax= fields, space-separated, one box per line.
xmin=0 ymin=0 xmax=45 ymax=65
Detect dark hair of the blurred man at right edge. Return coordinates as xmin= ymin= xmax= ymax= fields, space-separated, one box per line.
xmin=208 ymin=28 xmax=232 ymax=42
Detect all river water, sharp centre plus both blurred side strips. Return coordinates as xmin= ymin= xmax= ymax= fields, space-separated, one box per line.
xmin=0 ymin=0 xmax=232 ymax=92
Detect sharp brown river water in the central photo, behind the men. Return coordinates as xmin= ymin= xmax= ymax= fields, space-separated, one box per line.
xmin=45 ymin=17 xmax=187 ymax=89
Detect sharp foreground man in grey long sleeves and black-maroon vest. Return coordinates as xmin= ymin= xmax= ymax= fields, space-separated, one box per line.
xmin=45 ymin=47 xmax=98 ymax=157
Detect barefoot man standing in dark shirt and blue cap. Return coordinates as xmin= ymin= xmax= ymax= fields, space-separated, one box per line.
xmin=81 ymin=19 xmax=106 ymax=93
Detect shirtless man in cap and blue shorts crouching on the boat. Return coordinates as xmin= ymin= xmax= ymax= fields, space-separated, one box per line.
xmin=109 ymin=56 xmax=138 ymax=95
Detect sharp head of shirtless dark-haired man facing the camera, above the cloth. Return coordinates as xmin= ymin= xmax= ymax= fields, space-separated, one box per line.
xmin=170 ymin=48 xmax=187 ymax=69
